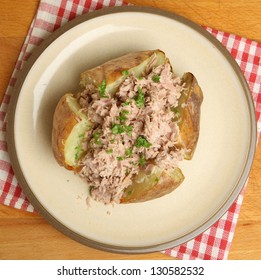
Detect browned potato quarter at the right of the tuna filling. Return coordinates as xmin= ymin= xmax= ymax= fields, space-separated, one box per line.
xmin=179 ymin=73 xmax=203 ymax=160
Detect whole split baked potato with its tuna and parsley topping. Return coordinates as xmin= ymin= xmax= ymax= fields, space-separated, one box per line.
xmin=52 ymin=50 xmax=203 ymax=204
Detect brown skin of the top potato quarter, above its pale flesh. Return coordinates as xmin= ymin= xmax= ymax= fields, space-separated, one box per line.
xmin=81 ymin=50 xmax=163 ymax=87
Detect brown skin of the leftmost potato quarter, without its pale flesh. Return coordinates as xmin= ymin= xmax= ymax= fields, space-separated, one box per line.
xmin=52 ymin=93 xmax=77 ymax=170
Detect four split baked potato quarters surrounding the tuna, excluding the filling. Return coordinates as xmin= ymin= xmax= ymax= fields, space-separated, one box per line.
xmin=52 ymin=50 xmax=203 ymax=204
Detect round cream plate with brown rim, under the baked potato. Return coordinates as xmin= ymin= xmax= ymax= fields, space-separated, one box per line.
xmin=8 ymin=7 xmax=256 ymax=252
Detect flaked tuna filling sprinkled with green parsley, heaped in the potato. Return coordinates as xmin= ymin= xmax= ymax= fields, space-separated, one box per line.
xmin=78 ymin=64 xmax=183 ymax=203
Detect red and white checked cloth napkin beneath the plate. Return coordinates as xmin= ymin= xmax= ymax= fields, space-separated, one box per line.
xmin=0 ymin=0 xmax=261 ymax=259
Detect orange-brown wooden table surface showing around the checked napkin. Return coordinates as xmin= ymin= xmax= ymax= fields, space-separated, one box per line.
xmin=0 ymin=0 xmax=261 ymax=259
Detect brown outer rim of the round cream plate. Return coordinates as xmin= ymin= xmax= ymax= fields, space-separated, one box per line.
xmin=6 ymin=6 xmax=257 ymax=254
